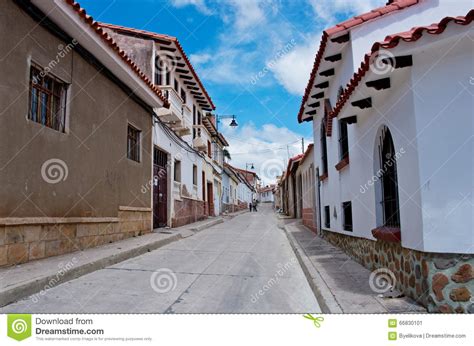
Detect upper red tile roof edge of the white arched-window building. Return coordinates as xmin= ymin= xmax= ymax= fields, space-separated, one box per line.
xmin=298 ymin=0 xmax=419 ymax=123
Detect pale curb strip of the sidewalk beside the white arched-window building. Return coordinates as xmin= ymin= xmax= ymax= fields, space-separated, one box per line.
xmin=282 ymin=224 xmax=344 ymax=314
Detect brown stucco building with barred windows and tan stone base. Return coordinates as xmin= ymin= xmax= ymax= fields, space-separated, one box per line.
xmin=0 ymin=0 xmax=169 ymax=266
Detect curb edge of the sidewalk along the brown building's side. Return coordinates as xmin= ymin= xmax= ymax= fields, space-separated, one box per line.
xmin=0 ymin=234 xmax=183 ymax=307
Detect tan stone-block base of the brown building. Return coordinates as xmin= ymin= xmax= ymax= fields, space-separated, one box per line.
xmin=0 ymin=209 xmax=151 ymax=266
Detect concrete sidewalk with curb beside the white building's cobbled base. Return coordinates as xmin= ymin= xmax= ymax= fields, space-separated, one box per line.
xmin=283 ymin=221 xmax=426 ymax=313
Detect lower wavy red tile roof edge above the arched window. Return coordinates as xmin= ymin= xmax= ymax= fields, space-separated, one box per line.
xmin=330 ymin=10 xmax=474 ymax=118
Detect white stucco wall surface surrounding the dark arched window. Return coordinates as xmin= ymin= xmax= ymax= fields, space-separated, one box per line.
xmin=313 ymin=14 xmax=474 ymax=253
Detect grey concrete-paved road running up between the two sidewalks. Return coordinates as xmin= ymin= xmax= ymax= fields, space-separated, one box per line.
xmin=0 ymin=206 xmax=320 ymax=313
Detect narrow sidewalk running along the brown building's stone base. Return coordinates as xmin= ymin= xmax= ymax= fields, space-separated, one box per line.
xmin=0 ymin=217 xmax=224 ymax=307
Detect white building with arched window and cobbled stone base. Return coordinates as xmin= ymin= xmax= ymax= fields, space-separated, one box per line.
xmin=298 ymin=0 xmax=474 ymax=311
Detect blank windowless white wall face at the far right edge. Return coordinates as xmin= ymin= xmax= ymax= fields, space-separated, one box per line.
xmin=412 ymin=25 xmax=474 ymax=253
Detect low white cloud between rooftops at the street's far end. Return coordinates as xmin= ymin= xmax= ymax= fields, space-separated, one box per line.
xmin=223 ymin=122 xmax=312 ymax=184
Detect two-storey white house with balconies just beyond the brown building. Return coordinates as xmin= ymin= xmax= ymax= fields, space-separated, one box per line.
xmin=101 ymin=23 xmax=228 ymax=227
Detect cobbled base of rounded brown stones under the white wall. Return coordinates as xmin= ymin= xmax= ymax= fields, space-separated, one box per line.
xmin=322 ymin=230 xmax=474 ymax=313
